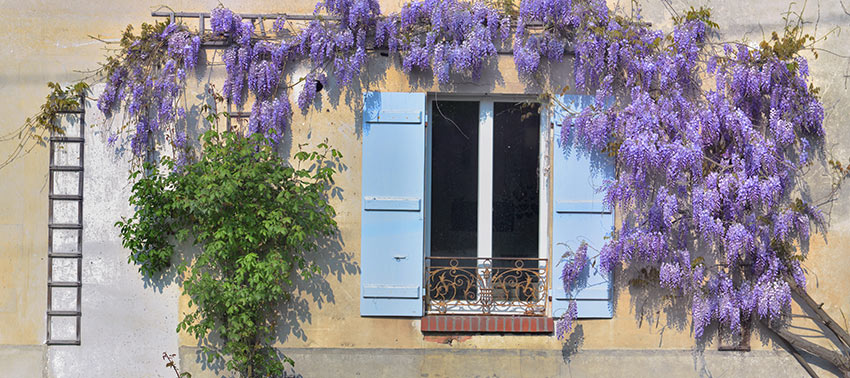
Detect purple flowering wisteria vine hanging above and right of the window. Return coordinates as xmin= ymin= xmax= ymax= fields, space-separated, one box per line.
xmin=93 ymin=0 xmax=824 ymax=346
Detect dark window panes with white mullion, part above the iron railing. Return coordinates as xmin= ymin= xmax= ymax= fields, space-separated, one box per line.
xmin=426 ymin=100 xmax=545 ymax=258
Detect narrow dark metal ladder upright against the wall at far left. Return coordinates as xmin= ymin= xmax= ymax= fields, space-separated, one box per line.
xmin=47 ymin=95 xmax=85 ymax=345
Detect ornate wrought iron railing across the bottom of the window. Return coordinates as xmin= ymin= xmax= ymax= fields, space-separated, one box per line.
xmin=425 ymin=257 xmax=549 ymax=316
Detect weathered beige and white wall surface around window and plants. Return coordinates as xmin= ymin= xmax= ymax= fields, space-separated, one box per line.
xmin=0 ymin=0 xmax=850 ymax=377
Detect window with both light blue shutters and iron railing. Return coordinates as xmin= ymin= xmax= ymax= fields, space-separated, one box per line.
xmin=360 ymin=92 xmax=613 ymax=318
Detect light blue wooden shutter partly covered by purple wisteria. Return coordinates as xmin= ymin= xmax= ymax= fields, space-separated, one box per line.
xmin=552 ymin=95 xmax=614 ymax=318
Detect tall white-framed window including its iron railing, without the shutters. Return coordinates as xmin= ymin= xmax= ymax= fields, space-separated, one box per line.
xmin=425 ymin=98 xmax=548 ymax=315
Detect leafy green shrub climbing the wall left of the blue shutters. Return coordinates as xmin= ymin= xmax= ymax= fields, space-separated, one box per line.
xmin=117 ymin=131 xmax=341 ymax=377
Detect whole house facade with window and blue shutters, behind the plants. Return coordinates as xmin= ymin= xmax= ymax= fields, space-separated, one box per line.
xmin=0 ymin=0 xmax=850 ymax=377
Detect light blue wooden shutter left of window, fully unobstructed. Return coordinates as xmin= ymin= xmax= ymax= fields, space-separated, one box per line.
xmin=360 ymin=92 xmax=425 ymax=316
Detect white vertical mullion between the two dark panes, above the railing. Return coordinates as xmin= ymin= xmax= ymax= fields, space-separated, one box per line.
xmin=478 ymin=100 xmax=493 ymax=258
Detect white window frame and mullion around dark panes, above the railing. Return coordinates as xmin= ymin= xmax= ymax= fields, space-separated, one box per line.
xmin=424 ymin=93 xmax=553 ymax=279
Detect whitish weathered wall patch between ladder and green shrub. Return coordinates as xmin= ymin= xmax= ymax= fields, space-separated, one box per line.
xmin=47 ymin=90 xmax=179 ymax=378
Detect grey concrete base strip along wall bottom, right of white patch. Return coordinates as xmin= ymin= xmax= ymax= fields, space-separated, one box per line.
xmin=180 ymin=347 xmax=830 ymax=378
